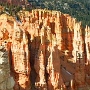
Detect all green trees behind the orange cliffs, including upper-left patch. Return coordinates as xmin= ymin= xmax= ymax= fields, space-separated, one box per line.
xmin=0 ymin=0 xmax=90 ymax=27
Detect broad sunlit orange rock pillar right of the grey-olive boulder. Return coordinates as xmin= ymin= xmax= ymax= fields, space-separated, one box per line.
xmin=11 ymin=22 xmax=30 ymax=90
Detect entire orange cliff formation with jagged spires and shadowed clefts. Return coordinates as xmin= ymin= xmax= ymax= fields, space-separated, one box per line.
xmin=0 ymin=9 xmax=90 ymax=90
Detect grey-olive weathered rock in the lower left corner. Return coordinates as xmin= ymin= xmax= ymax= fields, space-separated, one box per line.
xmin=0 ymin=46 xmax=15 ymax=90
